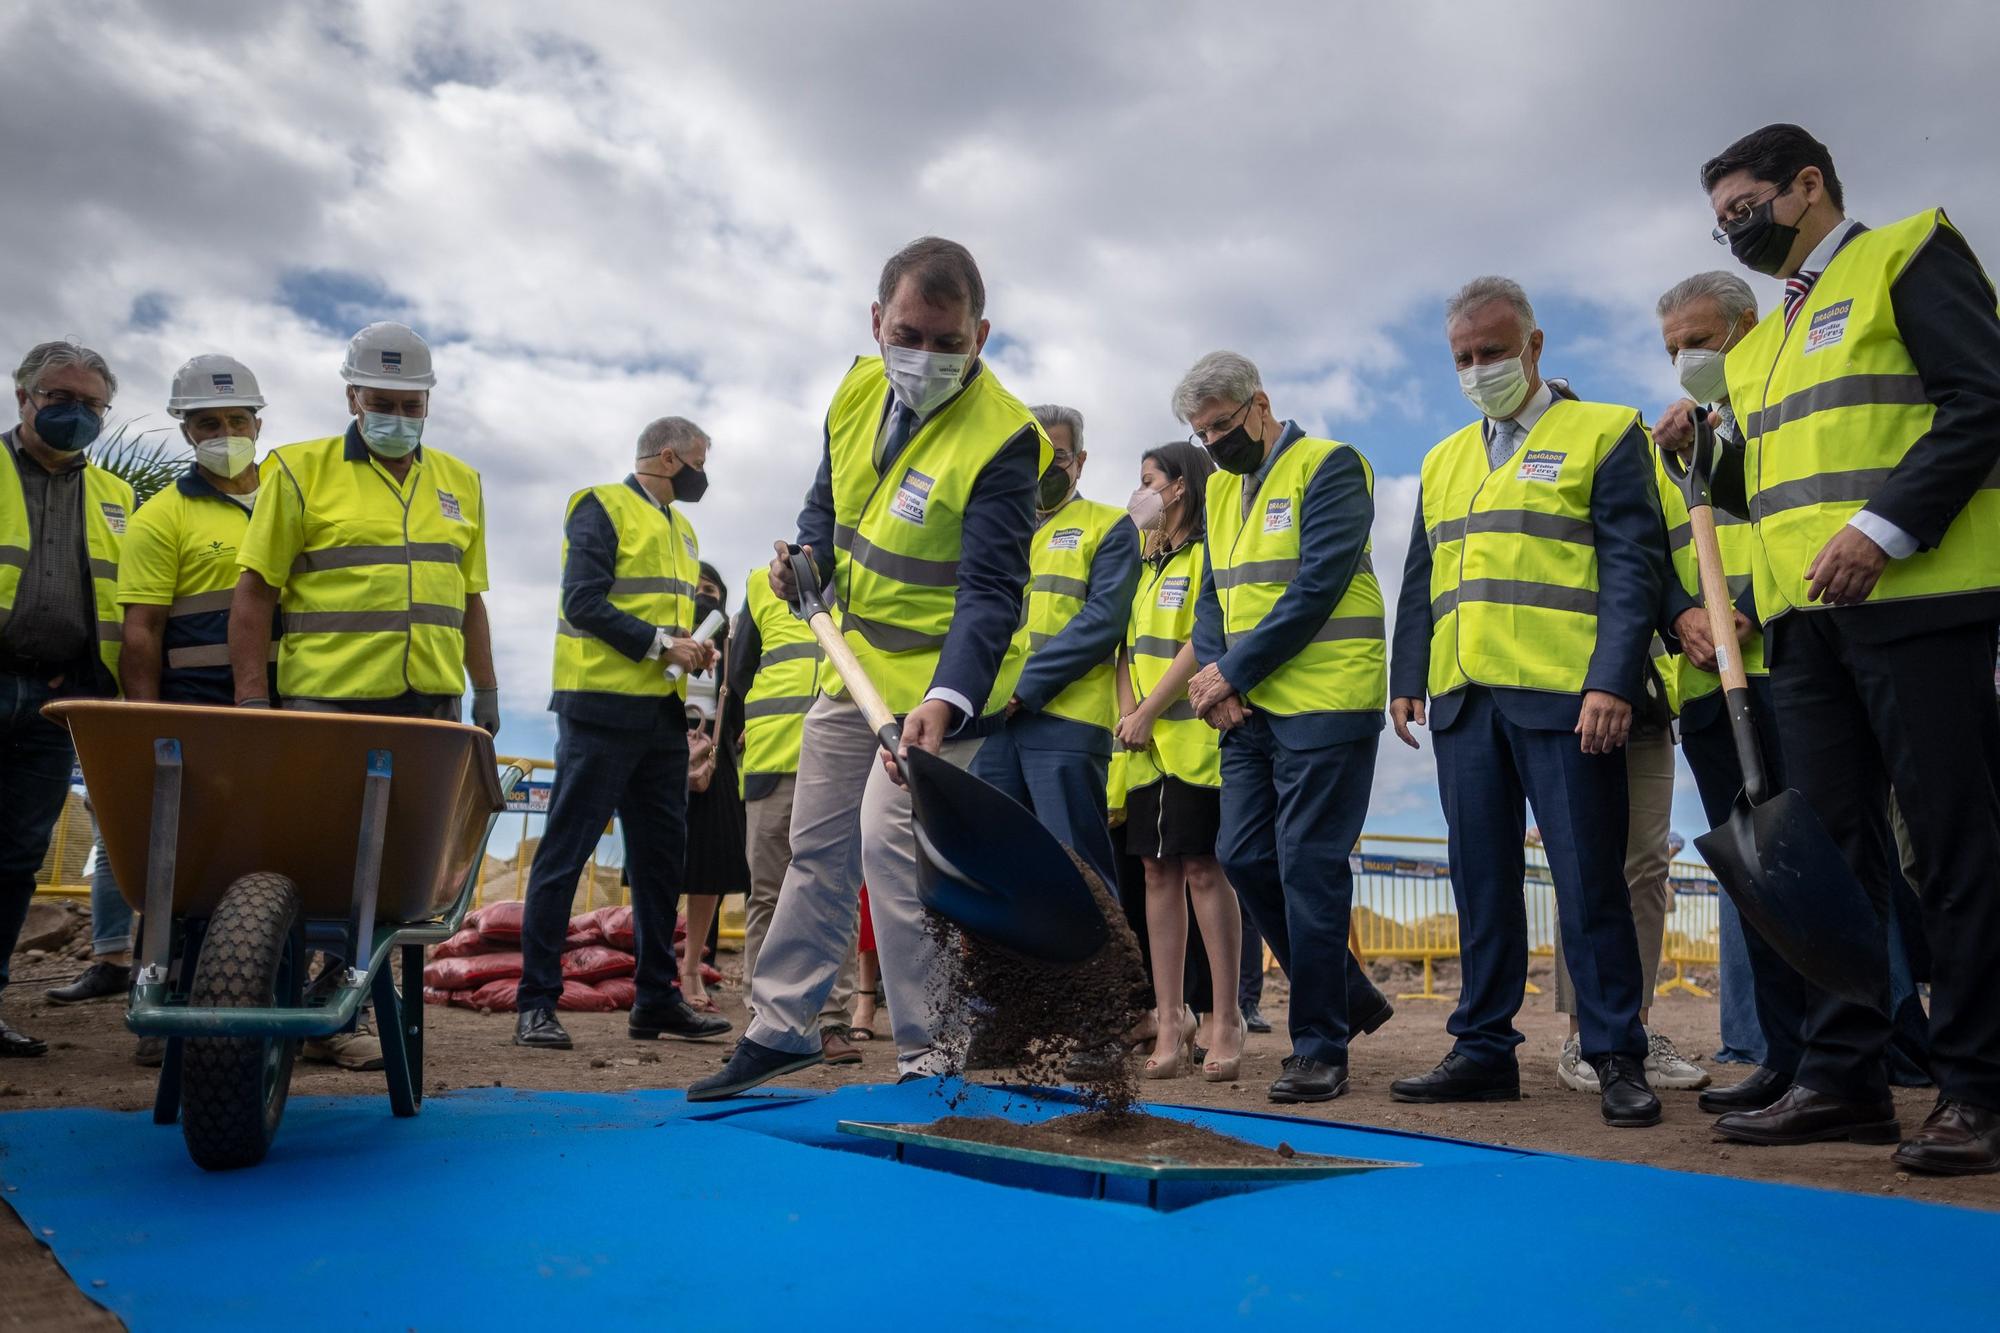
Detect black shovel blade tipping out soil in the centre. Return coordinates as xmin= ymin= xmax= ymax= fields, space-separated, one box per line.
xmin=904 ymin=749 xmax=1110 ymax=967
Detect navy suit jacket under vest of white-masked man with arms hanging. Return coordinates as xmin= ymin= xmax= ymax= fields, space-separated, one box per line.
xmin=1388 ymin=400 xmax=1668 ymax=733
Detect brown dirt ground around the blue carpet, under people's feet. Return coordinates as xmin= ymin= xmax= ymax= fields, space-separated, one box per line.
xmin=0 ymin=957 xmax=2000 ymax=1329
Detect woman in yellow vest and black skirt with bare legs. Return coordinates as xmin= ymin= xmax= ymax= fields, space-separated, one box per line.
xmin=1118 ymin=440 xmax=1244 ymax=1083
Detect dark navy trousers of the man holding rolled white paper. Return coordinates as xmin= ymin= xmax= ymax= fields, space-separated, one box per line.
xmin=514 ymin=709 xmax=702 ymax=1013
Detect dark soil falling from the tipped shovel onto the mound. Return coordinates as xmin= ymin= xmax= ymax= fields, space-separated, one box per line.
xmin=928 ymin=851 xmax=1152 ymax=1123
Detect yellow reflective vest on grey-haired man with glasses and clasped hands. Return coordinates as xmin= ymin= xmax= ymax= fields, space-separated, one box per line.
xmin=1208 ymin=436 xmax=1388 ymax=717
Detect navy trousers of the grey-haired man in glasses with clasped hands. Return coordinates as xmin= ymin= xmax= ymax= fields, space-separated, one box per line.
xmin=1216 ymin=713 xmax=1382 ymax=1065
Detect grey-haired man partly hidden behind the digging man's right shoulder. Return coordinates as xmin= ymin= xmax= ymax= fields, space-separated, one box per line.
xmin=972 ymin=404 xmax=1138 ymax=885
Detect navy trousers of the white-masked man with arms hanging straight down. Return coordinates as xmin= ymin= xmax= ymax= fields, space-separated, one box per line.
xmin=1434 ymin=687 xmax=1646 ymax=1069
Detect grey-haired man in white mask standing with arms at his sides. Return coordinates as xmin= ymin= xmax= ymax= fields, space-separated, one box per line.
xmin=1390 ymin=278 xmax=1666 ymax=1127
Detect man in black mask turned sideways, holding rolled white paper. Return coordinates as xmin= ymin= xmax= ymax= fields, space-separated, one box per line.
xmin=514 ymin=416 xmax=730 ymax=1051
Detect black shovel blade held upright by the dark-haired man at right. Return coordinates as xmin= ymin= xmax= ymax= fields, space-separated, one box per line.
xmin=1694 ymin=791 xmax=1888 ymax=1000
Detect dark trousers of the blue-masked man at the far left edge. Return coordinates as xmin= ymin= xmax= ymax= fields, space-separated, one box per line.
xmin=0 ymin=675 xmax=76 ymax=991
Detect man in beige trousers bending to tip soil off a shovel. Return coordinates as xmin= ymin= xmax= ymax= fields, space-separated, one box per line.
xmin=688 ymin=236 xmax=1052 ymax=1101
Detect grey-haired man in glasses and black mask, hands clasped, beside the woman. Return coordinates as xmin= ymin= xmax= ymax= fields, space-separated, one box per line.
xmin=1160 ymin=352 xmax=1392 ymax=1103
